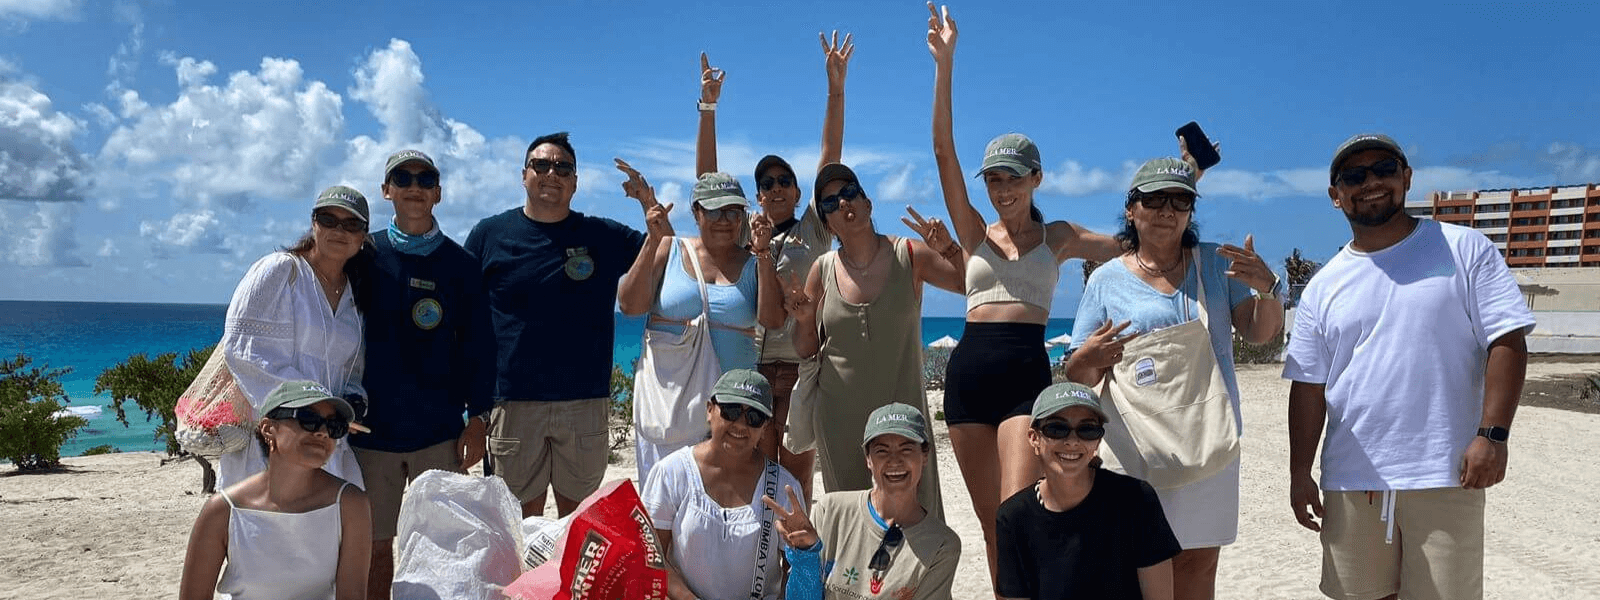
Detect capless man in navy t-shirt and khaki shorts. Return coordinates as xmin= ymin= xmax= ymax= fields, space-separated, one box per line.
xmin=467 ymin=133 xmax=672 ymax=517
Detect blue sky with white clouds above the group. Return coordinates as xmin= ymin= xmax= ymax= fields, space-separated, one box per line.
xmin=0 ymin=0 xmax=1600 ymax=317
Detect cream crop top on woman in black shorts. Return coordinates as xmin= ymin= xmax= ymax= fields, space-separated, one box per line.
xmin=966 ymin=222 xmax=1061 ymax=310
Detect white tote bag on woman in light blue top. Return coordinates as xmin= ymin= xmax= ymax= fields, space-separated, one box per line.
xmin=634 ymin=238 xmax=722 ymax=446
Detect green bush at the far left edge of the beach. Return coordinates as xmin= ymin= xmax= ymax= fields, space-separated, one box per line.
xmin=0 ymin=354 xmax=90 ymax=472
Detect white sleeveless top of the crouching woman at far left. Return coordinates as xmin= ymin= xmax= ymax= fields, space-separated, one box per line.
xmin=216 ymin=482 xmax=350 ymax=600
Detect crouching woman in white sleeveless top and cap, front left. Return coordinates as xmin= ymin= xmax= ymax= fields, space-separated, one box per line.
xmin=178 ymin=381 xmax=373 ymax=600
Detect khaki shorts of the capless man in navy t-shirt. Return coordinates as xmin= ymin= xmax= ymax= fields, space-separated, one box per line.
xmin=490 ymin=398 xmax=611 ymax=504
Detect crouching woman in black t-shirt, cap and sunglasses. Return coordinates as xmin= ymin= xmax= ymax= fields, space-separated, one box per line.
xmin=995 ymin=382 xmax=1181 ymax=600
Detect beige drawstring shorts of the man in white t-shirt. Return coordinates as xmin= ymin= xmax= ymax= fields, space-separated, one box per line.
xmin=1322 ymin=488 xmax=1483 ymax=600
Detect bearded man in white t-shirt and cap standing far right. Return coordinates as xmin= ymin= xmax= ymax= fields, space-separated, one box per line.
xmin=1283 ymin=134 xmax=1533 ymax=600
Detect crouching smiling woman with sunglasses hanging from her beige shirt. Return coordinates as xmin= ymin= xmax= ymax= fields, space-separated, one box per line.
xmin=762 ymin=402 xmax=962 ymax=600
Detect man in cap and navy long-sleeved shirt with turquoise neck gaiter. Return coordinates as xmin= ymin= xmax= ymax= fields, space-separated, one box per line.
xmin=350 ymin=150 xmax=494 ymax=598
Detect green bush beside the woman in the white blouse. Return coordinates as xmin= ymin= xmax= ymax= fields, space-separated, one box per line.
xmin=94 ymin=344 xmax=216 ymax=493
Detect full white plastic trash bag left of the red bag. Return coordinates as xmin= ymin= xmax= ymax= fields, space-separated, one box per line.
xmin=392 ymin=470 xmax=523 ymax=600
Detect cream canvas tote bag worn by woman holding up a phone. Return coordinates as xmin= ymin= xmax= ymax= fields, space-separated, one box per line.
xmin=1101 ymin=250 xmax=1238 ymax=490
